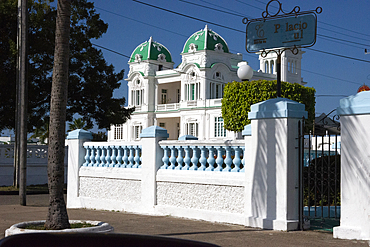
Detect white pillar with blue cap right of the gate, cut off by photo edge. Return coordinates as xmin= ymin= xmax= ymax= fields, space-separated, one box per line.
xmin=333 ymin=91 xmax=370 ymax=240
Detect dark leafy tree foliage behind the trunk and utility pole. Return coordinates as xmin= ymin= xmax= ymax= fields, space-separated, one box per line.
xmin=0 ymin=0 xmax=133 ymax=132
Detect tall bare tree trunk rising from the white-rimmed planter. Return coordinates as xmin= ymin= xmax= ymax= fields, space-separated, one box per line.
xmin=45 ymin=0 xmax=71 ymax=230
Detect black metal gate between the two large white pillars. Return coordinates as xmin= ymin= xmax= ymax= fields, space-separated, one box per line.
xmin=298 ymin=110 xmax=341 ymax=231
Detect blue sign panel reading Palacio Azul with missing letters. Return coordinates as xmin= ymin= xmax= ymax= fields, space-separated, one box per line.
xmin=246 ymin=14 xmax=317 ymax=52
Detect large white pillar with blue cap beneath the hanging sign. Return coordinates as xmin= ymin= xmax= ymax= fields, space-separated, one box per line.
xmin=245 ymin=98 xmax=307 ymax=231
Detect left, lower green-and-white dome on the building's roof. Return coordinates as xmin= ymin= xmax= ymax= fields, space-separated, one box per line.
xmin=129 ymin=37 xmax=172 ymax=63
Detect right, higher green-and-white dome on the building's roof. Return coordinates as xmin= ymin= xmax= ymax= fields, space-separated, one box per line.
xmin=182 ymin=25 xmax=229 ymax=53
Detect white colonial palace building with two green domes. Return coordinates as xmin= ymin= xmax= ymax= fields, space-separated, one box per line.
xmin=108 ymin=26 xmax=305 ymax=141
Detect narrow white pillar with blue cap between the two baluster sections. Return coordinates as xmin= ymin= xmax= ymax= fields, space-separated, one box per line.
xmin=140 ymin=126 xmax=169 ymax=210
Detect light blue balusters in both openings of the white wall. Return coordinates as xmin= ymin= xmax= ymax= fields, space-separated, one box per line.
xmin=82 ymin=142 xmax=245 ymax=172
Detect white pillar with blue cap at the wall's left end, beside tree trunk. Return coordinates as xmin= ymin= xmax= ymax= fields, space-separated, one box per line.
xmin=67 ymin=129 xmax=93 ymax=208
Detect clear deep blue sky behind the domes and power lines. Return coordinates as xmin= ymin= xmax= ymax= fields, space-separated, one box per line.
xmin=92 ymin=0 xmax=370 ymax=117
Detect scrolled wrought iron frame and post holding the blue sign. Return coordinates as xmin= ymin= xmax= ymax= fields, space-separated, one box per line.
xmin=242 ymin=0 xmax=322 ymax=97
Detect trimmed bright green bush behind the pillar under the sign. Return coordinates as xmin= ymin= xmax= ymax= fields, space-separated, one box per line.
xmin=221 ymin=80 xmax=316 ymax=131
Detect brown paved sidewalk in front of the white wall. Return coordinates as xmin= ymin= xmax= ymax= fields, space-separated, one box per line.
xmin=0 ymin=195 xmax=369 ymax=247
